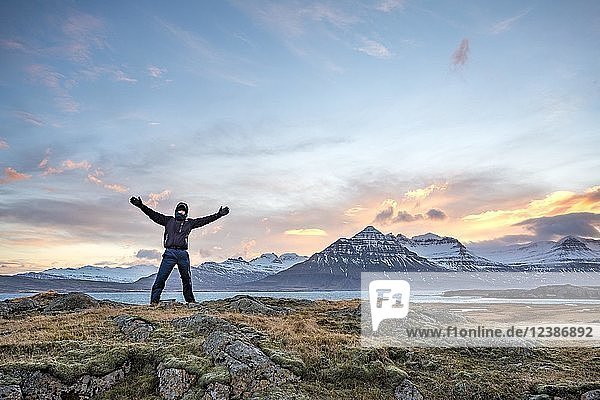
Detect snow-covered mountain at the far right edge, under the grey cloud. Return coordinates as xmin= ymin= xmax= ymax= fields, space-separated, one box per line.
xmin=472 ymin=236 xmax=600 ymax=270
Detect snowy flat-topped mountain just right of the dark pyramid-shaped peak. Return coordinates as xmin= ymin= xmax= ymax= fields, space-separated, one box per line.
xmin=396 ymin=233 xmax=506 ymax=271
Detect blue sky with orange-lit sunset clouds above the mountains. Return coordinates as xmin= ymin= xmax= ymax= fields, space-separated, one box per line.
xmin=0 ymin=0 xmax=600 ymax=274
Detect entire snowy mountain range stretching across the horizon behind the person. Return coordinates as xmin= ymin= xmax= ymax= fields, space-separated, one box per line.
xmin=0 ymin=226 xmax=600 ymax=292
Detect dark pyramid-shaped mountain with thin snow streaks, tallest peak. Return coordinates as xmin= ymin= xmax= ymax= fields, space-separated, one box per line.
xmin=247 ymin=226 xmax=447 ymax=290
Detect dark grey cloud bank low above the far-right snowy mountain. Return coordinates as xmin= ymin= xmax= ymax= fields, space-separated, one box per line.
xmin=514 ymin=212 xmax=600 ymax=240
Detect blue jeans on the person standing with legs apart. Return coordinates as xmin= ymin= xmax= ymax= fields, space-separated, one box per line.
xmin=150 ymin=249 xmax=195 ymax=303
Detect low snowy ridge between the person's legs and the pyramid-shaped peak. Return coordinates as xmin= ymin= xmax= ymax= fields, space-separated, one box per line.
xmin=137 ymin=253 xmax=308 ymax=290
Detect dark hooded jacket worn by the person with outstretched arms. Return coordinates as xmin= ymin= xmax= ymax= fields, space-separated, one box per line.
xmin=140 ymin=202 xmax=221 ymax=250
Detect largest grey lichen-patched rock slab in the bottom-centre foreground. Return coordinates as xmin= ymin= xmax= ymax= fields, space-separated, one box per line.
xmin=203 ymin=330 xmax=299 ymax=398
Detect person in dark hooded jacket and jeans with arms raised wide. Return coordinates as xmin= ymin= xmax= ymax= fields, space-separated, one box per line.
xmin=129 ymin=197 xmax=229 ymax=305
